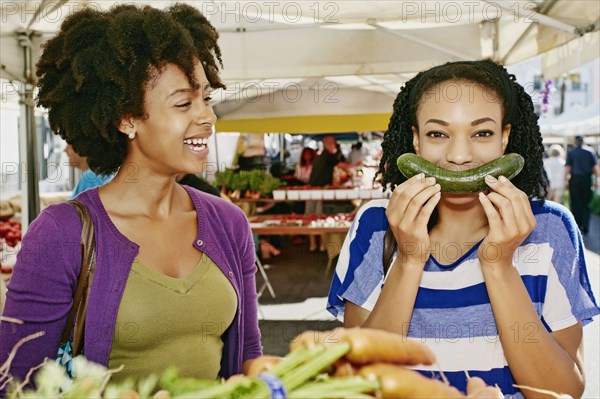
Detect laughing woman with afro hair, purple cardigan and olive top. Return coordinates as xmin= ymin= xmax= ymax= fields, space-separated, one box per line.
xmin=0 ymin=4 xmax=262 ymax=386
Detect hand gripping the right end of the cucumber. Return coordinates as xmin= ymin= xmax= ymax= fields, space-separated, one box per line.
xmin=477 ymin=175 xmax=536 ymax=266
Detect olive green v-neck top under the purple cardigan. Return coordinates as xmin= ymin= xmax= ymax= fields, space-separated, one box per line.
xmin=108 ymin=254 xmax=237 ymax=380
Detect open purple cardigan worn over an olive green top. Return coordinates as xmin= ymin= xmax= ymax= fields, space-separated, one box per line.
xmin=0 ymin=186 xmax=262 ymax=386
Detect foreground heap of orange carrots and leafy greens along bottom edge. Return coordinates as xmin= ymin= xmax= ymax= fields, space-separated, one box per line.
xmin=0 ymin=328 xmax=503 ymax=399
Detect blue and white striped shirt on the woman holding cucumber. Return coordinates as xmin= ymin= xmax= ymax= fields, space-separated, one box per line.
xmin=327 ymin=200 xmax=600 ymax=398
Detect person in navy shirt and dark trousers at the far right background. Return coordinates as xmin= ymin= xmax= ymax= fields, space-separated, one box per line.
xmin=565 ymin=136 xmax=600 ymax=234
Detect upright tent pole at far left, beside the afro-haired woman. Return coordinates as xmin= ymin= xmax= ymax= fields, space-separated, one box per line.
xmin=17 ymin=31 xmax=40 ymax=225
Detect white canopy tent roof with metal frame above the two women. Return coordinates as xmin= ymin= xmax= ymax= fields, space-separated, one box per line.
xmin=0 ymin=0 xmax=600 ymax=225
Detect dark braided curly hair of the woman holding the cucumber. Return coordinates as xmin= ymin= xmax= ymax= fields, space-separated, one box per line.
xmin=375 ymin=60 xmax=548 ymax=273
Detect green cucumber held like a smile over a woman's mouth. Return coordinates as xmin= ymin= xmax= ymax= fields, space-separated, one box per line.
xmin=396 ymin=153 xmax=525 ymax=194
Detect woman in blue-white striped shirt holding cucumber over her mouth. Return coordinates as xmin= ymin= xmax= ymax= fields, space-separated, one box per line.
xmin=328 ymin=61 xmax=600 ymax=397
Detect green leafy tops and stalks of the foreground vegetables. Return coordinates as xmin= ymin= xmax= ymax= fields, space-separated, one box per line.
xmin=7 ymin=343 xmax=378 ymax=399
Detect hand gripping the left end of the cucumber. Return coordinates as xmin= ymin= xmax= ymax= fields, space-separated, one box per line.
xmin=385 ymin=173 xmax=441 ymax=265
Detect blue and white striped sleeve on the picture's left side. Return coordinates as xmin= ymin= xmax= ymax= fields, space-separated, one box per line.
xmin=327 ymin=200 xmax=388 ymax=321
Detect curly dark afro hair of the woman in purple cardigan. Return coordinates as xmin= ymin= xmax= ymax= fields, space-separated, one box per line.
xmin=37 ymin=4 xmax=225 ymax=174
